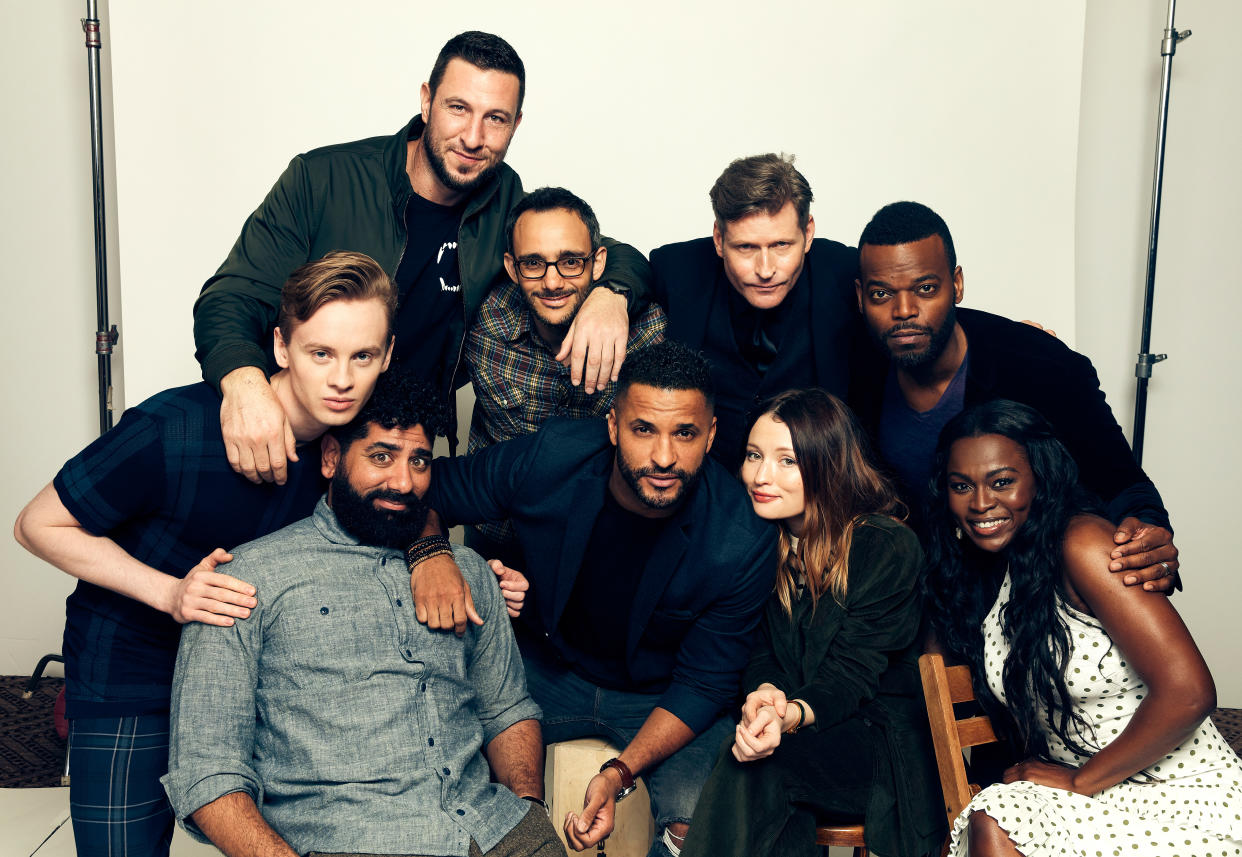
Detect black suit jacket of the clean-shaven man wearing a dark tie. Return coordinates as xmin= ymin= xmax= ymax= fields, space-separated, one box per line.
xmin=651 ymin=237 xmax=858 ymax=467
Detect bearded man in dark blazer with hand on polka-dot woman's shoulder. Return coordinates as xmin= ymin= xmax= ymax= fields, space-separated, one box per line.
xmin=850 ymin=202 xmax=1179 ymax=590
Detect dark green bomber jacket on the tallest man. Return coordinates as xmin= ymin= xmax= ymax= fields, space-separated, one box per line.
xmin=194 ymin=117 xmax=651 ymax=390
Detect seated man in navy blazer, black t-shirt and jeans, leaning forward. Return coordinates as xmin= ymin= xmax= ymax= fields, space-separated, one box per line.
xmin=427 ymin=342 xmax=776 ymax=855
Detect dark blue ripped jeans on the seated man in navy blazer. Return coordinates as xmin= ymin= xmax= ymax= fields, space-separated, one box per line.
xmin=523 ymin=651 xmax=733 ymax=857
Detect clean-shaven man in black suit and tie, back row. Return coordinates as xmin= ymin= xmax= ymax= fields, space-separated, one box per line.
xmin=651 ymin=154 xmax=857 ymax=472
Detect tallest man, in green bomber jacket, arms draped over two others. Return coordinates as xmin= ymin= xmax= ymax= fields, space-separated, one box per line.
xmin=194 ymin=32 xmax=650 ymax=482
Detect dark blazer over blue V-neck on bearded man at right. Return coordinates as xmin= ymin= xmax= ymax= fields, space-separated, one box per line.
xmin=850 ymin=307 xmax=1170 ymax=528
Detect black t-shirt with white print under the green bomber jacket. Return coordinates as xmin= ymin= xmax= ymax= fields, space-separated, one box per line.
xmin=392 ymin=194 xmax=465 ymax=380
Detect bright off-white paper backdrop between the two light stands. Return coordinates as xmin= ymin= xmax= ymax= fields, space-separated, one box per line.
xmin=111 ymin=0 xmax=1084 ymax=401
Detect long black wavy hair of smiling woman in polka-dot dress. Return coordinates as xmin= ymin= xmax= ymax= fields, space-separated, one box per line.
xmin=924 ymin=400 xmax=1098 ymax=760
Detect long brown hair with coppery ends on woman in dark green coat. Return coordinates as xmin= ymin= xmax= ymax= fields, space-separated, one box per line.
xmin=751 ymin=388 xmax=905 ymax=615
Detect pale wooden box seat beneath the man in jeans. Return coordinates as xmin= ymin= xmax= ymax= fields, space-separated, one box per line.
xmin=544 ymin=738 xmax=656 ymax=857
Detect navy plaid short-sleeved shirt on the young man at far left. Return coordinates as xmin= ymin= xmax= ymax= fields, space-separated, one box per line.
xmin=53 ymin=383 xmax=323 ymax=717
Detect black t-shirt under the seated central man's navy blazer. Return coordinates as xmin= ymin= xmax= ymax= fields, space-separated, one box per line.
xmin=559 ymin=492 xmax=669 ymax=688
